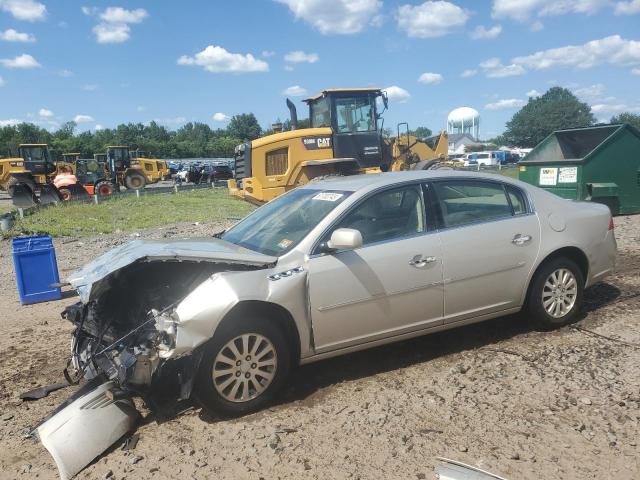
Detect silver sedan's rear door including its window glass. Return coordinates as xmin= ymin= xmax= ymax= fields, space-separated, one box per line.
xmin=429 ymin=180 xmax=540 ymax=322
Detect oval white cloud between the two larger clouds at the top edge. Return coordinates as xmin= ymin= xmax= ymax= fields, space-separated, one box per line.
xmin=396 ymin=1 xmax=469 ymax=38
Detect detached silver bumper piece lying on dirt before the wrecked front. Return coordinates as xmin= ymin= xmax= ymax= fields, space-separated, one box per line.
xmin=35 ymin=382 xmax=139 ymax=480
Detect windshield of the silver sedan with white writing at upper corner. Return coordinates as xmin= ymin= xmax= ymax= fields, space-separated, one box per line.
xmin=221 ymin=189 xmax=351 ymax=256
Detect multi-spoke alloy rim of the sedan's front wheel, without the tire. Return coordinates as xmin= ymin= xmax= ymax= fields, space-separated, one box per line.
xmin=212 ymin=333 xmax=278 ymax=403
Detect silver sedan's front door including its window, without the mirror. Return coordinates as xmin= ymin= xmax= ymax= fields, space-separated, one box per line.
xmin=307 ymin=185 xmax=443 ymax=353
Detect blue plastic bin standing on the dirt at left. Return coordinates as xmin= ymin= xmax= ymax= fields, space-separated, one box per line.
xmin=13 ymin=235 xmax=62 ymax=305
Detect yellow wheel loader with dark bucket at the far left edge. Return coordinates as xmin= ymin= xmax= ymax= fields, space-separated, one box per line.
xmin=0 ymin=143 xmax=82 ymax=208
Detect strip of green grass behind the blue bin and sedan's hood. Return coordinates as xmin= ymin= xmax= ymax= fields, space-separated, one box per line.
xmin=11 ymin=188 xmax=255 ymax=237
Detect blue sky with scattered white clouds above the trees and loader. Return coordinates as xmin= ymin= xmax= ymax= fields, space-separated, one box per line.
xmin=0 ymin=0 xmax=640 ymax=138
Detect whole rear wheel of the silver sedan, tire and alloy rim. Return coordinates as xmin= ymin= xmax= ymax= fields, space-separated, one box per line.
xmin=527 ymin=257 xmax=584 ymax=330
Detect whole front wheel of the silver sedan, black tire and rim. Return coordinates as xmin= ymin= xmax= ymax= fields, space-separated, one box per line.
xmin=194 ymin=317 xmax=291 ymax=417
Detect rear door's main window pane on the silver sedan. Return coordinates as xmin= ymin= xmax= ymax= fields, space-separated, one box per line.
xmin=434 ymin=181 xmax=512 ymax=227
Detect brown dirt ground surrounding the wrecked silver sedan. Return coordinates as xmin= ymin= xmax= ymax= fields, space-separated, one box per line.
xmin=0 ymin=215 xmax=640 ymax=480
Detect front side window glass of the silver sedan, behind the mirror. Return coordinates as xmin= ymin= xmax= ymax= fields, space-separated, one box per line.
xmin=333 ymin=185 xmax=425 ymax=245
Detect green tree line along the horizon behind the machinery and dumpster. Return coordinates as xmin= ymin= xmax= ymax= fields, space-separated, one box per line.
xmin=0 ymin=87 xmax=640 ymax=158
